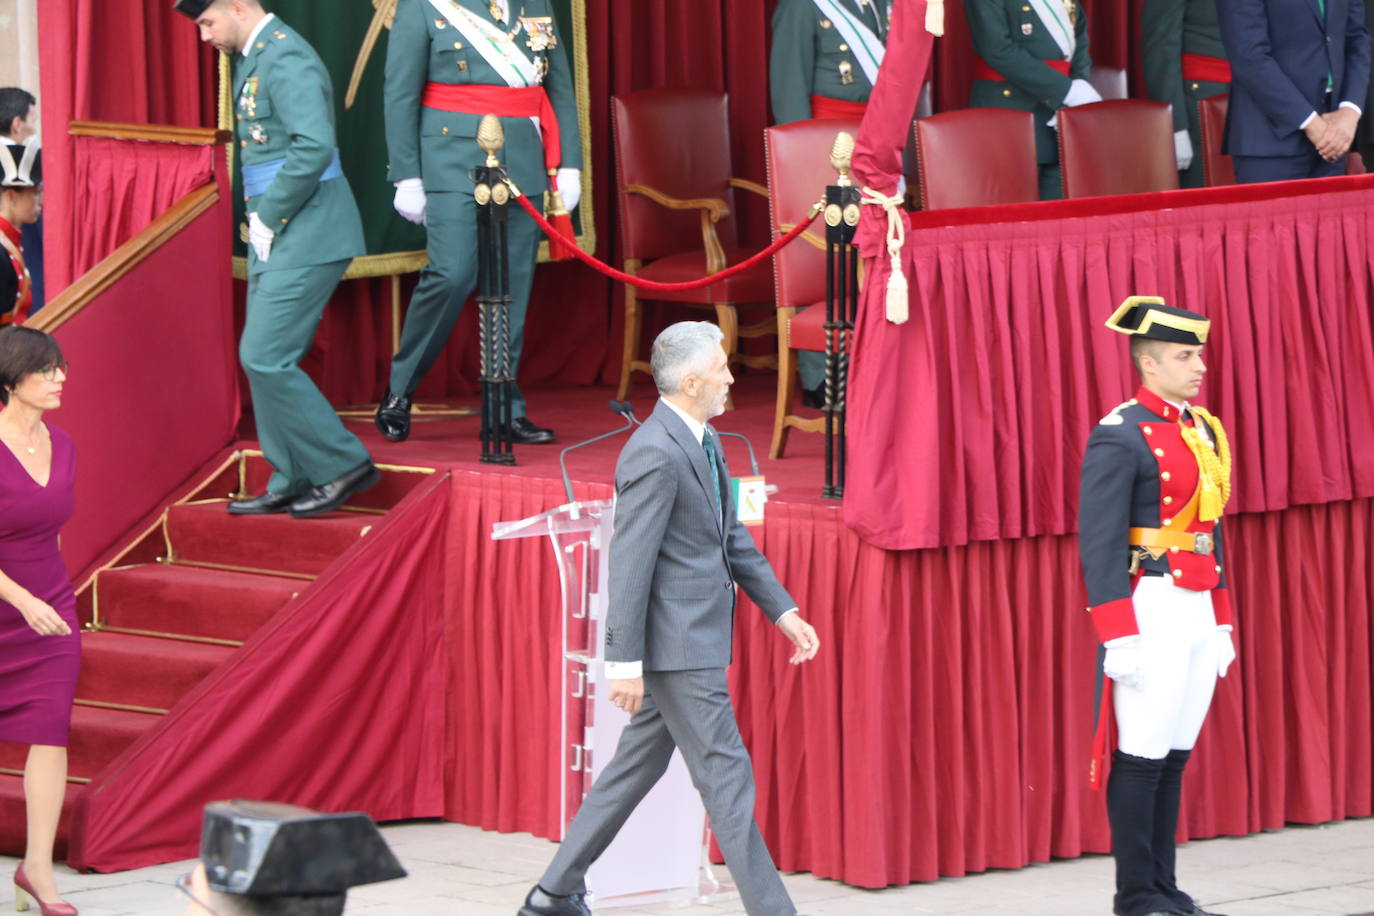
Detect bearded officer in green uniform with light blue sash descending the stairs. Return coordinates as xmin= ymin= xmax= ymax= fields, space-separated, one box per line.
xmin=176 ymin=0 xmax=379 ymax=518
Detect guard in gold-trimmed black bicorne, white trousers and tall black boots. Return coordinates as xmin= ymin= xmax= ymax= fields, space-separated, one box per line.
xmin=1079 ymin=297 xmax=1235 ymax=916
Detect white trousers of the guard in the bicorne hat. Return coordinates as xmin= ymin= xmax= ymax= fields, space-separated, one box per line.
xmin=1112 ymin=575 xmax=1217 ymax=759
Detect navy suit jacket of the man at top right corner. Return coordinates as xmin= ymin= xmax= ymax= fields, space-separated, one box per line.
xmin=1216 ymin=0 xmax=1370 ymax=157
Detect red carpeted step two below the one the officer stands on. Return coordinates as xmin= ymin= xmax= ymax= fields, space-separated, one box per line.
xmin=77 ymin=633 xmax=234 ymax=709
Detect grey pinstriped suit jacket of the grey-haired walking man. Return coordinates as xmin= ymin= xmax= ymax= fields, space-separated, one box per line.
xmin=605 ymin=401 xmax=797 ymax=672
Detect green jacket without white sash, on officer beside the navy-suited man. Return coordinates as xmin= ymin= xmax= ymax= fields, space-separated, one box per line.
xmin=1140 ymin=0 xmax=1227 ymax=133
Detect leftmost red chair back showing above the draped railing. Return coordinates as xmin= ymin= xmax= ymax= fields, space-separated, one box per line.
xmin=912 ymin=108 xmax=1040 ymax=210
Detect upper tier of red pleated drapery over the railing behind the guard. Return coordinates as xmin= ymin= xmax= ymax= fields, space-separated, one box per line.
xmin=845 ymin=176 xmax=1374 ymax=549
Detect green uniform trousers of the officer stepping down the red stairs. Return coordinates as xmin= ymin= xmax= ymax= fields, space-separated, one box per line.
xmin=239 ymin=260 xmax=370 ymax=494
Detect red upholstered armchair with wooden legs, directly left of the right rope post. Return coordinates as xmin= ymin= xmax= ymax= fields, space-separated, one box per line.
xmin=764 ymin=119 xmax=859 ymax=459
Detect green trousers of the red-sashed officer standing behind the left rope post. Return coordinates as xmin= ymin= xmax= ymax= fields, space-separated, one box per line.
xmin=392 ymin=191 xmax=541 ymax=419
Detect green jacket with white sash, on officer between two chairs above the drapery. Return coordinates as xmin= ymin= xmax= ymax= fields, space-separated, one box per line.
xmin=963 ymin=0 xmax=1092 ymax=163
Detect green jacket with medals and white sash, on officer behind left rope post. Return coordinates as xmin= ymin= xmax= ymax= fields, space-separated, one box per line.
xmin=385 ymin=0 xmax=583 ymax=195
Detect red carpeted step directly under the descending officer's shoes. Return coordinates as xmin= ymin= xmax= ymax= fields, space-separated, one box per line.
xmin=166 ymin=503 xmax=381 ymax=575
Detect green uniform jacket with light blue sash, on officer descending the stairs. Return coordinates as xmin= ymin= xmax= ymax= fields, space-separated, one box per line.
xmin=234 ymin=16 xmax=365 ymax=275
